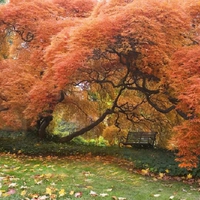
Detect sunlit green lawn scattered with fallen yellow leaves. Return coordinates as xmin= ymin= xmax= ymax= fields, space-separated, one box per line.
xmin=0 ymin=154 xmax=200 ymax=200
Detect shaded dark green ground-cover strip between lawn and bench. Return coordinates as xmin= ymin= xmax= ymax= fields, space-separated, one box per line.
xmin=0 ymin=132 xmax=200 ymax=178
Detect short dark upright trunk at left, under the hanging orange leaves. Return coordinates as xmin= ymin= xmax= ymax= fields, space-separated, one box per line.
xmin=38 ymin=116 xmax=53 ymax=138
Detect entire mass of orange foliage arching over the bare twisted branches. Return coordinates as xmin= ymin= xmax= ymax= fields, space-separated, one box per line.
xmin=0 ymin=0 xmax=200 ymax=166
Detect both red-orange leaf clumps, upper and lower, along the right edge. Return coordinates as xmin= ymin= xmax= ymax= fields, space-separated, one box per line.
xmin=168 ymin=45 xmax=200 ymax=167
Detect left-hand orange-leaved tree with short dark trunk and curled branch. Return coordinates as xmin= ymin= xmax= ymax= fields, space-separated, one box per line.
xmin=0 ymin=0 xmax=97 ymax=136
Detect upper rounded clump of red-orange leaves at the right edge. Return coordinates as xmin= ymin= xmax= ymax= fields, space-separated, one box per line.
xmin=168 ymin=46 xmax=200 ymax=113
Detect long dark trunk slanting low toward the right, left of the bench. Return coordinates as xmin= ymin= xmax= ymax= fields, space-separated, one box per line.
xmin=59 ymin=109 xmax=113 ymax=143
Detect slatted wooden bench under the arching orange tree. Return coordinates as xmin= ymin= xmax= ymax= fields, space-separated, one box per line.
xmin=119 ymin=131 xmax=157 ymax=148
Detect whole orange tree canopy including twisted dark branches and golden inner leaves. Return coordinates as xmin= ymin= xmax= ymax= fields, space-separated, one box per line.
xmin=0 ymin=0 xmax=200 ymax=167
